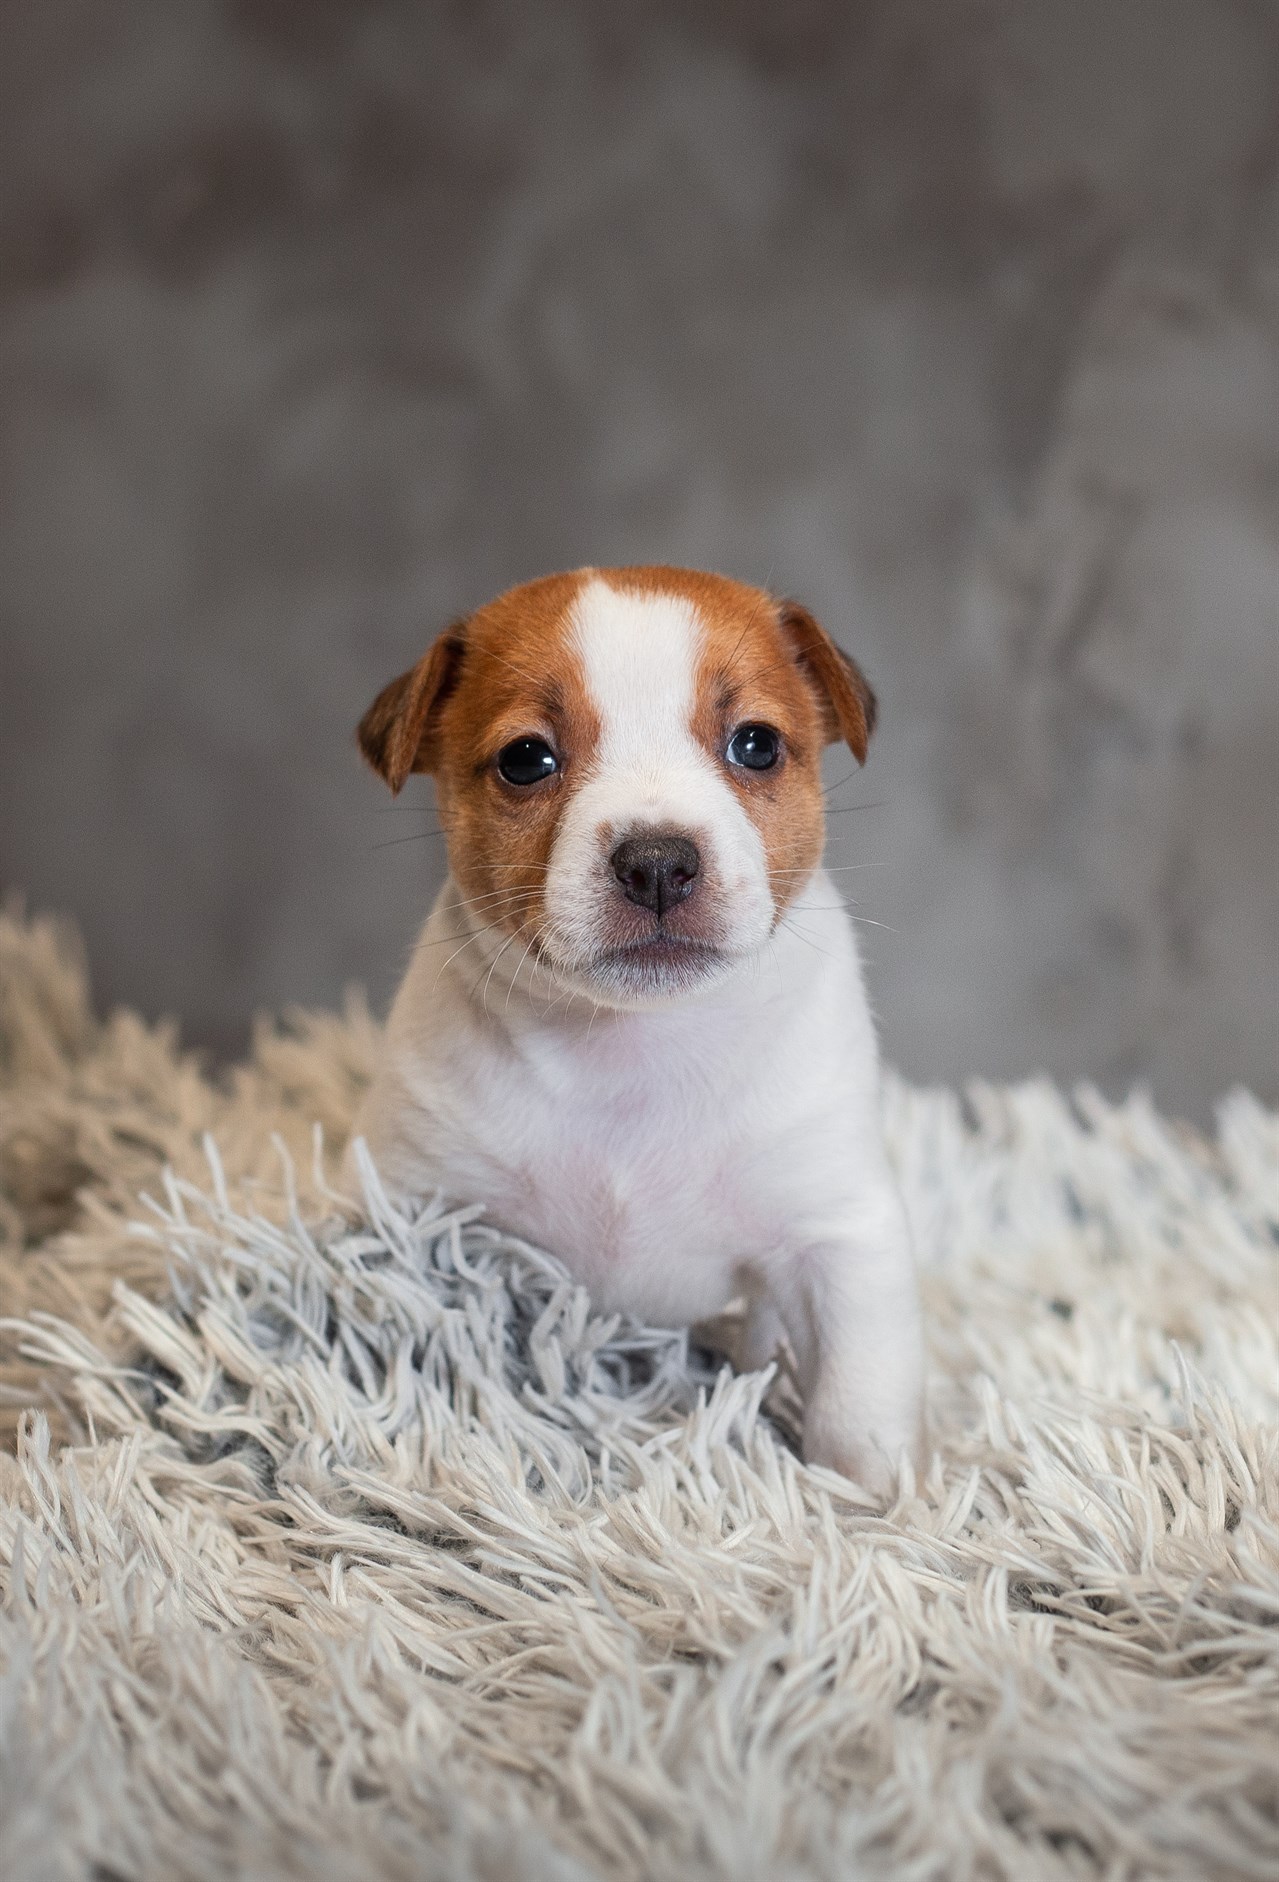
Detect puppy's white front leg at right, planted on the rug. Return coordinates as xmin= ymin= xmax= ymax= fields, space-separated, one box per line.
xmin=781 ymin=1178 xmax=924 ymax=1496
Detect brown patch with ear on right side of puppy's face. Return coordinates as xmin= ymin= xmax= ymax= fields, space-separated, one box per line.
xmin=602 ymin=566 xmax=875 ymax=911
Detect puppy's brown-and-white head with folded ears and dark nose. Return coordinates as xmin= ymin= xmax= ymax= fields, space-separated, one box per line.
xmin=359 ymin=568 xmax=875 ymax=1007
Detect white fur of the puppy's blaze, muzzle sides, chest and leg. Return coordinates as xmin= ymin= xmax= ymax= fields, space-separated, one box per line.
xmin=357 ymin=583 xmax=922 ymax=1489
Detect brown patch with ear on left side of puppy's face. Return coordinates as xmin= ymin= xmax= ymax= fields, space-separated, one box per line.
xmin=359 ymin=570 xmax=600 ymax=947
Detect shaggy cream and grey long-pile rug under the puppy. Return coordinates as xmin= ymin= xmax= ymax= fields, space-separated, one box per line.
xmin=0 ymin=915 xmax=1279 ymax=1882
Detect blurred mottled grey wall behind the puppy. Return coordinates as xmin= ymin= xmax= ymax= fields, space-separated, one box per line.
xmin=0 ymin=0 xmax=1279 ymax=1118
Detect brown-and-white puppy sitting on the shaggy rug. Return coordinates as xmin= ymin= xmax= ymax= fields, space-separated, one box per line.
xmin=355 ymin=568 xmax=922 ymax=1496
